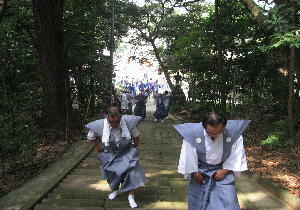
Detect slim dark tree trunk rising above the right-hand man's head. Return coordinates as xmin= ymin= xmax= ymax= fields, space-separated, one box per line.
xmin=215 ymin=0 xmax=227 ymax=112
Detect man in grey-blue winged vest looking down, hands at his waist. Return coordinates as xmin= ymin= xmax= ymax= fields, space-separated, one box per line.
xmin=174 ymin=111 xmax=250 ymax=210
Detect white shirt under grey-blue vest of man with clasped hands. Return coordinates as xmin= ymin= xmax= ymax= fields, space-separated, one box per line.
xmin=178 ymin=130 xmax=248 ymax=177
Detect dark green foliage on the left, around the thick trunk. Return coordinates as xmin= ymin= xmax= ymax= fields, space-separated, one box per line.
xmin=0 ymin=0 xmax=128 ymax=195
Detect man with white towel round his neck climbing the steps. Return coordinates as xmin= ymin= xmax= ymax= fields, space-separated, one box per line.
xmin=85 ymin=106 xmax=146 ymax=208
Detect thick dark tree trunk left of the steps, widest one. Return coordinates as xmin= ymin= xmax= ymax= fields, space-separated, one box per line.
xmin=32 ymin=0 xmax=77 ymax=140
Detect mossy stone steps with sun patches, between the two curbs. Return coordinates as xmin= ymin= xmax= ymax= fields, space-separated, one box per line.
xmin=34 ymin=103 xmax=290 ymax=210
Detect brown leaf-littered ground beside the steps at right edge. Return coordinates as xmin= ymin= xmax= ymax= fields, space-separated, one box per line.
xmin=246 ymin=146 xmax=300 ymax=197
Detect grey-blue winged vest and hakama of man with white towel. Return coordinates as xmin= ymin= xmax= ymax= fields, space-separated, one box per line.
xmin=86 ymin=115 xmax=146 ymax=193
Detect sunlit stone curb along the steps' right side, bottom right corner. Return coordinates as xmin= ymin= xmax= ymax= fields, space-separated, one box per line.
xmin=245 ymin=171 xmax=300 ymax=209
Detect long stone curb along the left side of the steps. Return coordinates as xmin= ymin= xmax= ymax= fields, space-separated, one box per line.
xmin=0 ymin=140 xmax=93 ymax=210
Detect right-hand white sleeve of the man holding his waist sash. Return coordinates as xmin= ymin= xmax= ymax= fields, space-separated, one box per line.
xmin=223 ymin=136 xmax=248 ymax=172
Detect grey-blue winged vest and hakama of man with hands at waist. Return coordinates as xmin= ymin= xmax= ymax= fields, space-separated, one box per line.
xmin=174 ymin=120 xmax=250 ymax=210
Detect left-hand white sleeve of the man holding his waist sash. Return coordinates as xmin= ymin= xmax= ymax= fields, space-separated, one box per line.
xmin=178 ymin=139 xmax=198 ymax=178
